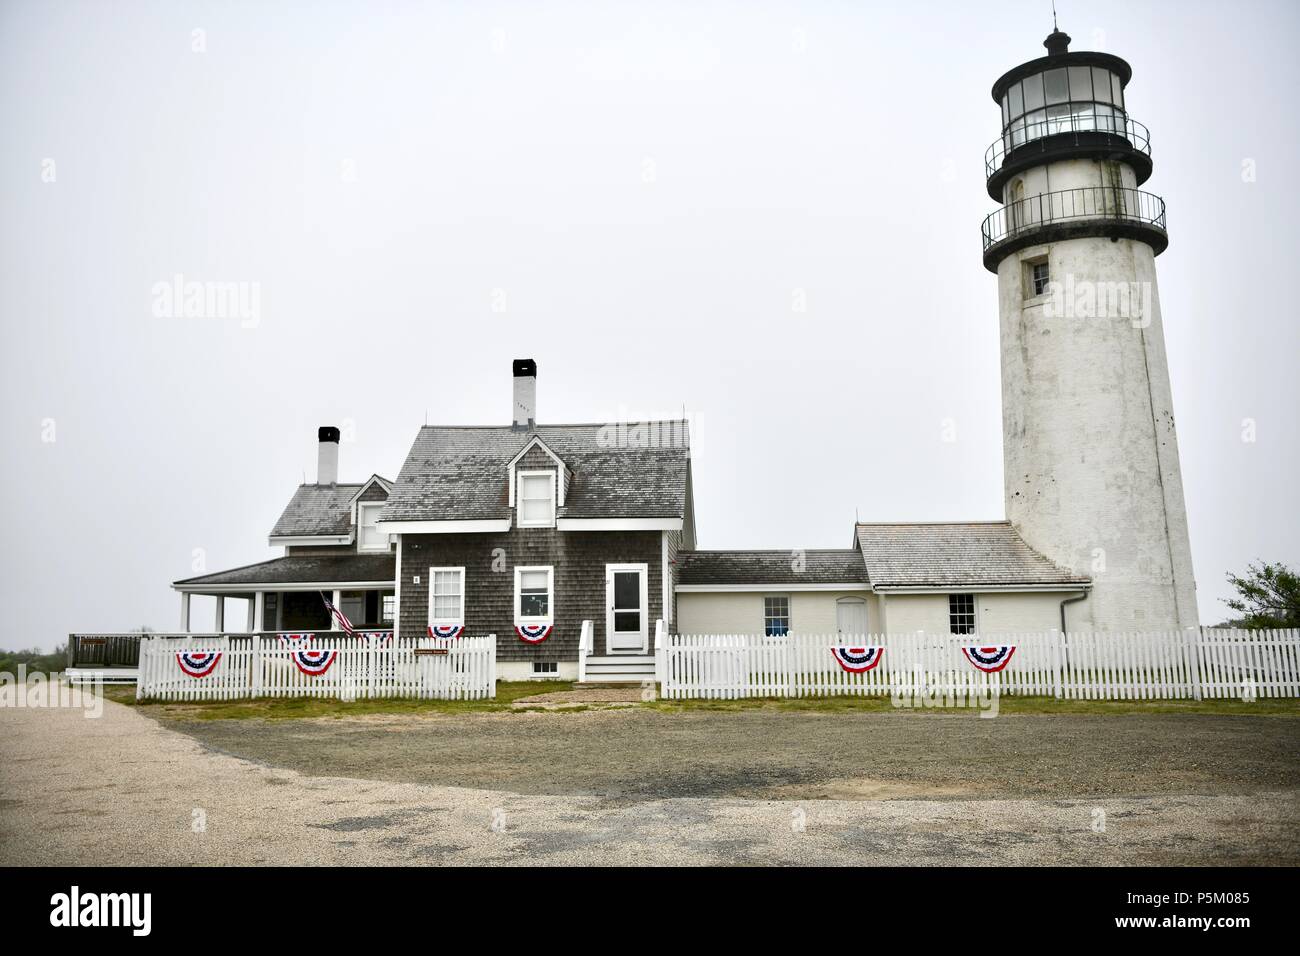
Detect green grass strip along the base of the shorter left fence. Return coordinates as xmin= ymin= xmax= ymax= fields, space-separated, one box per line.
xmin=104 ymin=680 xmax=573 ymax=721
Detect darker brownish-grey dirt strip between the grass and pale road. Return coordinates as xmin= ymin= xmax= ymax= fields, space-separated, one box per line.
xmin=169 ymin=709 xmax=1300 ymax=801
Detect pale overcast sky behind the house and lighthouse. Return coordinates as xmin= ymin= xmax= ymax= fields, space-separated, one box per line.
xmin=0 ymin=0 xmax=1300 ymax=648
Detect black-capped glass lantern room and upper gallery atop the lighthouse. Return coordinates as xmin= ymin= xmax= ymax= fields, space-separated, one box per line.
xmin=984 ymin=30 xmax=1152 ymax=200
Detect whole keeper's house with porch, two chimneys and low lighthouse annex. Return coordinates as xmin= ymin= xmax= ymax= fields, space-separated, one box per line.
xmin=173 ymin=359 xmax=1091 ymax=680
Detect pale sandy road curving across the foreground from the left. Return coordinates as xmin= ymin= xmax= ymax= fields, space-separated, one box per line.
xmin=0 ymin=704 xmax=1300 ymax=865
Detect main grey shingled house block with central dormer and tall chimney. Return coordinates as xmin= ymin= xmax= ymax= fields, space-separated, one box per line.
xmin=380 ymin=359 xmax=694 ymax=679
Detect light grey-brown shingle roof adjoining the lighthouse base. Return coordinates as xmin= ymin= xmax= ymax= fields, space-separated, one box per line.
xmin=855 ymin=522 xmax=1091 ymax=589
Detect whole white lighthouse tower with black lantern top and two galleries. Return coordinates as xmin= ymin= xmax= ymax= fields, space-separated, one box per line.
xmin=984 ymin=30 xmax=1197 ymax=631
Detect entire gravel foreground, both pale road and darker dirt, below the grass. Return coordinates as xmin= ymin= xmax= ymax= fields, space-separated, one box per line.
xmin=0 ymin=702 xmax=1300 ymax=865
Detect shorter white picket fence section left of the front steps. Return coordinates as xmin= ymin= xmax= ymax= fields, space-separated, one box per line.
xmin=135 ymin=633 xmax=497 ymax=701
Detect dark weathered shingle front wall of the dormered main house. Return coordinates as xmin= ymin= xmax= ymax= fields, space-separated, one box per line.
xmin=399 ymin=528 xmax=663 ymax=661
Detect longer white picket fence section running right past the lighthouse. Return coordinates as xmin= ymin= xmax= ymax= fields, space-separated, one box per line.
xmin=655 ymin=628 xmax=1300 ymax=700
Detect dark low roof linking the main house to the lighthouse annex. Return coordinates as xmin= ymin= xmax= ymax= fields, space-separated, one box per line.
xmin=677 ymin=548 xmax=867 ymax=589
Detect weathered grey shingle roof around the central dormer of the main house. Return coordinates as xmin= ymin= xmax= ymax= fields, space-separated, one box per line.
xmin=380 ymin=421 xmax=690 ymax=522
